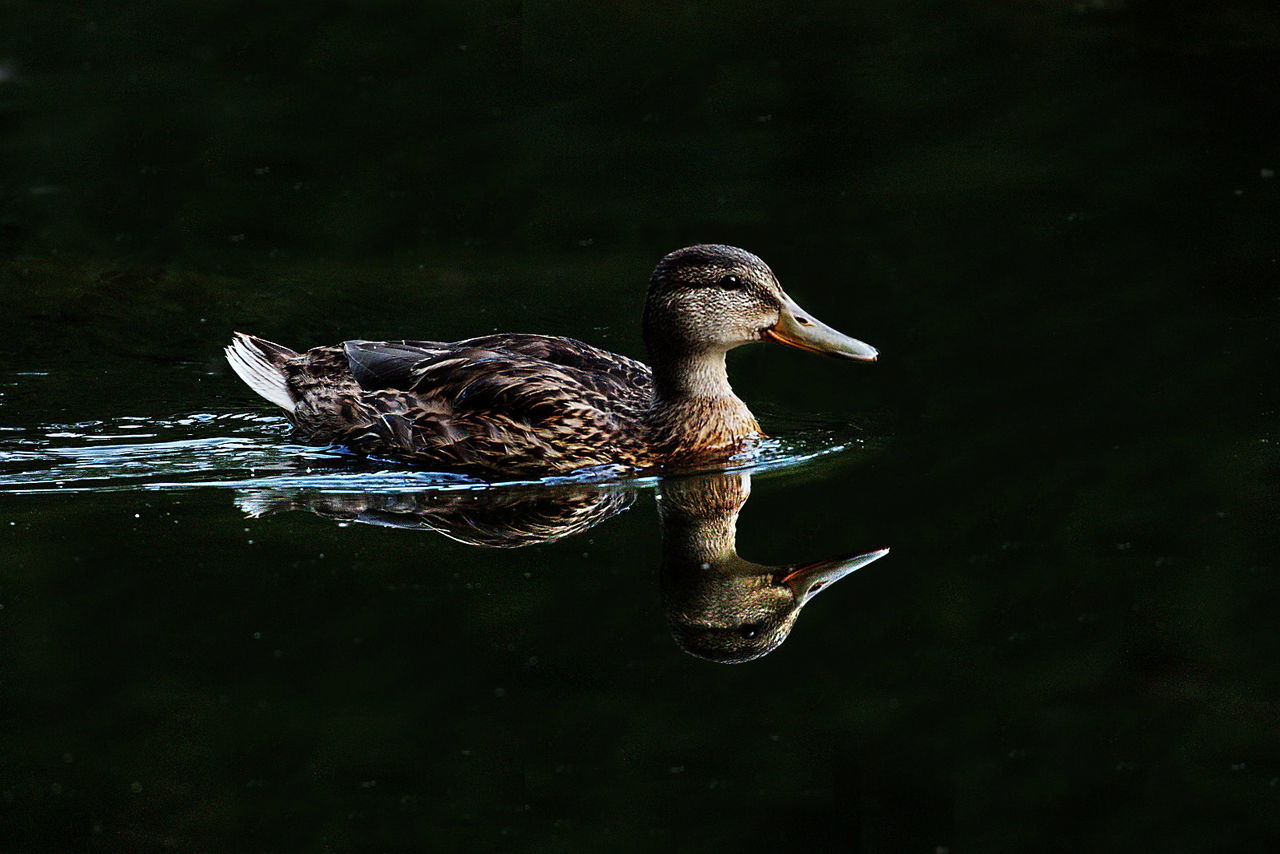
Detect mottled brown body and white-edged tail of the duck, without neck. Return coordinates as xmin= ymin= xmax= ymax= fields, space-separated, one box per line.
xmin=228 ymin=334 xmax=653 ymax=474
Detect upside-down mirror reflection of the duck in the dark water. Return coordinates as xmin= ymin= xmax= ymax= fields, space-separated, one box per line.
xmin=237 ymin=472 xmax=888 ymax=663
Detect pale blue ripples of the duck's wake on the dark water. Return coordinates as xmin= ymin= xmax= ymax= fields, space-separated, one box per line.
xmin=0 ymin=412 xmax=864 ymax=494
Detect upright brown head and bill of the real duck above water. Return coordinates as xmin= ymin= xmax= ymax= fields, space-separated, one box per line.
xmin=644 ymin=243 xmax=877 ymax=362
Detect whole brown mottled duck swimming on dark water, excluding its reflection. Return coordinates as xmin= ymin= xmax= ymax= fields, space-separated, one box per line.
xmin=227 ymin=245 xmax=877 ymax=475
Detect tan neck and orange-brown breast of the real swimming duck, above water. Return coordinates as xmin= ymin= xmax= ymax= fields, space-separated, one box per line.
xmin=648 ymin=351 xmax=763 ymax=462
